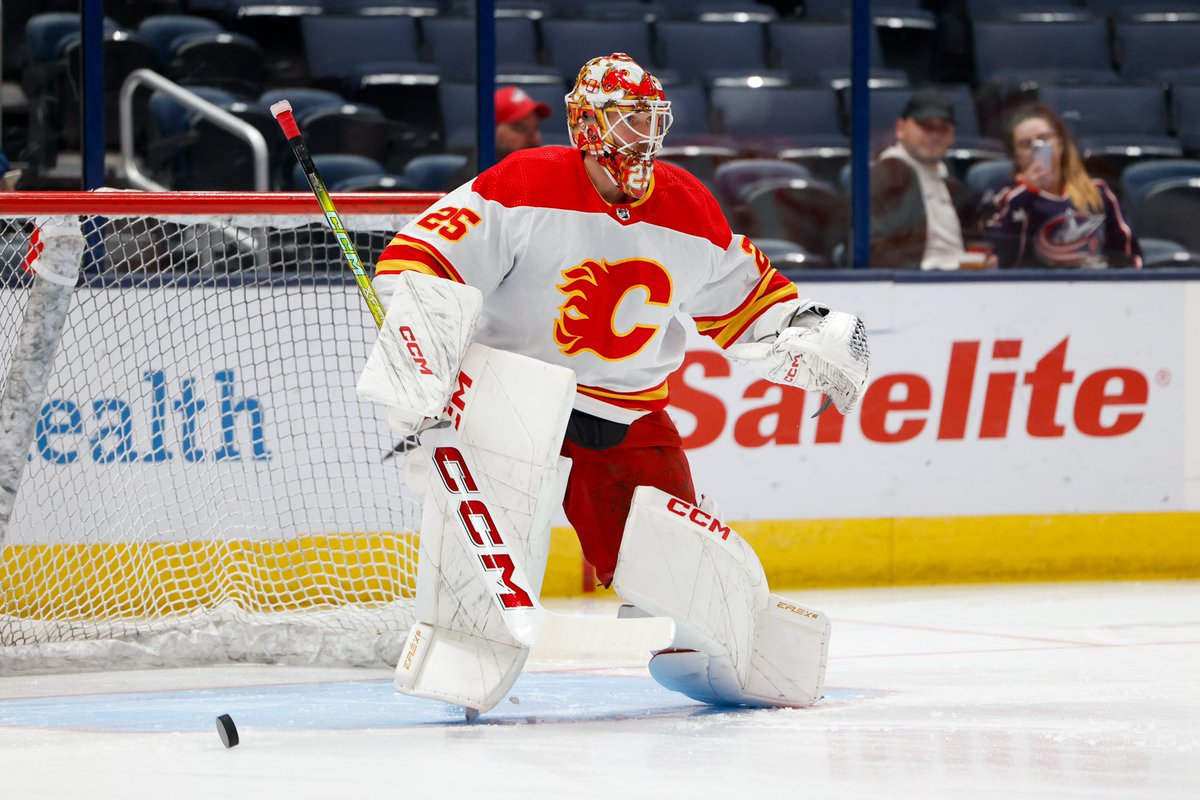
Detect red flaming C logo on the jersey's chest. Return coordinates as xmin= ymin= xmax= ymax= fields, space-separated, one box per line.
xmin=554 ymin=258 xmax=672 ymax=361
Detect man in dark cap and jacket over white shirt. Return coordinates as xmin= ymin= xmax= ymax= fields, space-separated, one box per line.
xmin=871 ymin=89 xmax=970 ymax=270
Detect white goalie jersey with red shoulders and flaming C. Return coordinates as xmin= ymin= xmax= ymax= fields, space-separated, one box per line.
xmin=374 ymin=148 xmax=797 ymax=422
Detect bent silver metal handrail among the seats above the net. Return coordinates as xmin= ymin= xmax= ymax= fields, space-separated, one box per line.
xmin=120 ymin=70 xmax=271 ymax=192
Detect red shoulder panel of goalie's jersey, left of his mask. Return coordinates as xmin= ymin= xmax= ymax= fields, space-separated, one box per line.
xmin=472 ymin=146 xmax=587 ymax=210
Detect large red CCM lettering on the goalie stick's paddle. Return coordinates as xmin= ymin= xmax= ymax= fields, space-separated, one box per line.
xmin=433 ymin=447 xmax=534 ymax=608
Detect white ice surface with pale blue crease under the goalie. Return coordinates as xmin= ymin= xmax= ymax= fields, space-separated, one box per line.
xmin=0 ymin=582 xmax=1200 ymax=800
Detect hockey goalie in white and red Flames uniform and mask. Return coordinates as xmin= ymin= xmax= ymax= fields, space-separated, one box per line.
xmin=358 ymin=53 xmax=869 ymax=715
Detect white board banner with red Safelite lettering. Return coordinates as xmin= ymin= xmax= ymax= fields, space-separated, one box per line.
xmin=671 ymin=282 xmax=1198 ymax=519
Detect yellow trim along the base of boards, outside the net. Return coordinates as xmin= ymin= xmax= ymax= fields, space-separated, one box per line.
xmin=544 ymin=512 xmax=1200 ymax=596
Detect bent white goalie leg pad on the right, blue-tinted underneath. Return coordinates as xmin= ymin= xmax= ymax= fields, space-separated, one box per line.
xmin=613 ymin=487 xmax=829 ymax=706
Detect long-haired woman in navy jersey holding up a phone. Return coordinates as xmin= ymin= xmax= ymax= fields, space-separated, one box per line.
xmin=983 ymin=103 xmax=1141 ymax=269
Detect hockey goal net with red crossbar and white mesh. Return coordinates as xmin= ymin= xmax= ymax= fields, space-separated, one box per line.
xmin=0 ymin=192 xmax=433 ymax=673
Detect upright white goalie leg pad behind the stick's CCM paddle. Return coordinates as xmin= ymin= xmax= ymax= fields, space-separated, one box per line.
xmin=395 ymin=344 xmax=575 ymax=711
